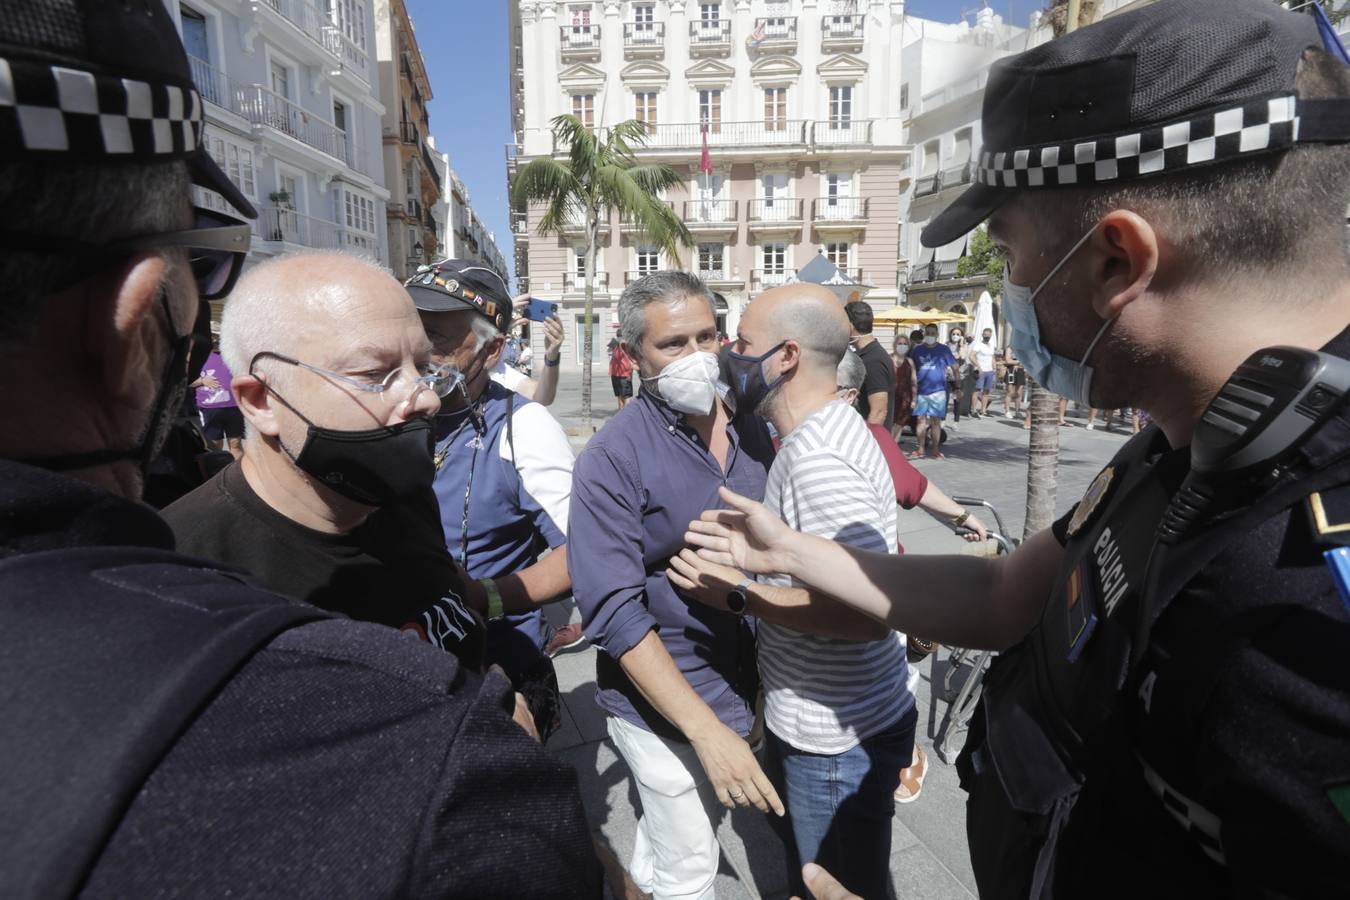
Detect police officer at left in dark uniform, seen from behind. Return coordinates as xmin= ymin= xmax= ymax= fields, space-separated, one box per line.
xmin=0 ymin=0 xmax=601 ymax=897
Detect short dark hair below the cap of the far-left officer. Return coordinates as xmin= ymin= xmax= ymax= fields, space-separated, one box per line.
xmin=0 ymin=158 xmax=192 ymax=349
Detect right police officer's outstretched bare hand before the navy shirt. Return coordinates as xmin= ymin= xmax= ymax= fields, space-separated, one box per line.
xmin=684 ymin=487 xmax=798 ymax=575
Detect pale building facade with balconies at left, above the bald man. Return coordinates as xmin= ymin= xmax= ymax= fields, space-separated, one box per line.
xmin=166 ymin=0 xmax=389 ymax=266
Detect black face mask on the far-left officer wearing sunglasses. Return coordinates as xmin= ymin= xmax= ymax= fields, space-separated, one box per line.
xmin=19 ymin=291 xmax=211 ymax=475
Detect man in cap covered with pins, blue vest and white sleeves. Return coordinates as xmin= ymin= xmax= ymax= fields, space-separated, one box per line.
xmin=405 ymin=259 xmax=583 ymax=739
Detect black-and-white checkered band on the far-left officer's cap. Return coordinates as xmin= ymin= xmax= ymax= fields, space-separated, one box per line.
xmin=0 ymin=57 xmax=203 ymax=159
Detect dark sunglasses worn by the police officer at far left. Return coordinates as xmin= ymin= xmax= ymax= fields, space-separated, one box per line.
xmin=0 ymin=206 xmax=252 ymax=300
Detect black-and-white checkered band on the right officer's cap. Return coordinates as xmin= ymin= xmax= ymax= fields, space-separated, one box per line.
xmin=976 ymin=94 xmax=1299 ymax=188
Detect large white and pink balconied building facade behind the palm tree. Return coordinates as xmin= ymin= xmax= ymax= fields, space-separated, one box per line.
xmin=506 ymin=0 xmax=909 ymax=366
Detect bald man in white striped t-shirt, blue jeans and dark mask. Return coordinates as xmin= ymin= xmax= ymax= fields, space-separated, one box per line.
xmin=671 ymin=285 xmax=918 ymax=899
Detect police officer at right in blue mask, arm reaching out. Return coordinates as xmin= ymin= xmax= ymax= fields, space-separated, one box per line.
xmin=690 ymin=0 xmax=1350 ymax=897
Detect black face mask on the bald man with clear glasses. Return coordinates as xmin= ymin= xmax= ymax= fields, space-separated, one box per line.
xmin=267 ymin=385 xmax=436 ymax=506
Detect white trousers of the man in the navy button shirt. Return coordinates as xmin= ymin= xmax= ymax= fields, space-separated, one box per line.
xmin=609 ymin=715 xmax=722 ymax=900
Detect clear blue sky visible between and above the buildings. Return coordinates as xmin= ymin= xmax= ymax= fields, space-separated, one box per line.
xmin=406 ymin=0 xmax=1049 ymax=282
